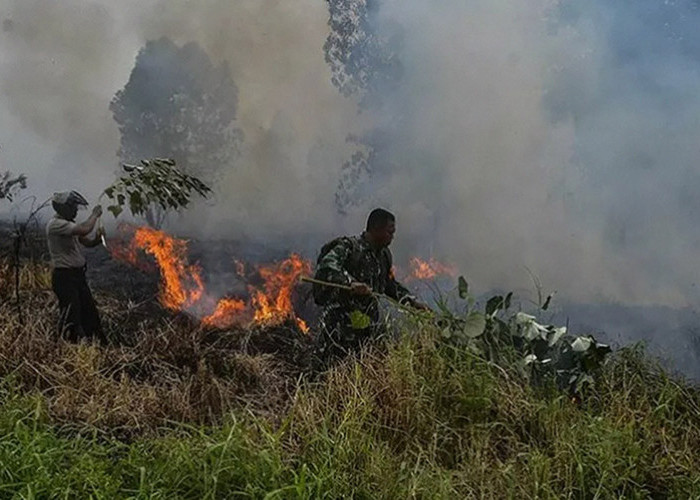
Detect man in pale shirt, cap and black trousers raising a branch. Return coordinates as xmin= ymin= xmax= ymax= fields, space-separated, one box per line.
xmin=46 ymin=191 xmax=105 ymax=342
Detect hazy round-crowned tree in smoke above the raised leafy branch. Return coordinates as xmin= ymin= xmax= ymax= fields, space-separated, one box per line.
xmin=110 ymin=38 xmax=242 ymax=223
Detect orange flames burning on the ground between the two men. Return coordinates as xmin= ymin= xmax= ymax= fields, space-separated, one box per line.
xmin=112 ymin=227 xmax=311 ymax=332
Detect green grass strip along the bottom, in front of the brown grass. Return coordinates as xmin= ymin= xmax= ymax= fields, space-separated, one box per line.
xmin=0 ymin=325 xmax=700 ymax=499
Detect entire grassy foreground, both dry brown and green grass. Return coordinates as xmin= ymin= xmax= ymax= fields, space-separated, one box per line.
xmin=0 ymin=258 xmax=700 ymax=498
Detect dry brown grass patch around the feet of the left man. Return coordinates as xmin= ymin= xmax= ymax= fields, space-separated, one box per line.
xmin=0 ymin=264 xmax=306 ymax=436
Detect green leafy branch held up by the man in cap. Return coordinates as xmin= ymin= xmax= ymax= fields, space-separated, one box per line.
xmin=104 ymin=158 xmax=211 ymax=217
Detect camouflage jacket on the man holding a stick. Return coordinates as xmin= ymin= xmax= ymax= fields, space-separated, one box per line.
xmin=316 ymin=235 xmax=415 ymax=321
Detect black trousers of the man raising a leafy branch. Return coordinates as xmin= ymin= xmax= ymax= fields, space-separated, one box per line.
xmin=51 ymin=268 xmax=105 ymax=342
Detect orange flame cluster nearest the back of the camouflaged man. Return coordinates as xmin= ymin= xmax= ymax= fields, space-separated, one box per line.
xmin=251 ymin=254 xmax=311 ymax=332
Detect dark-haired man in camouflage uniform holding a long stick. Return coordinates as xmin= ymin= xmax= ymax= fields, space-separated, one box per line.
xmin=314 ymin=208 xmax=427 ymax=364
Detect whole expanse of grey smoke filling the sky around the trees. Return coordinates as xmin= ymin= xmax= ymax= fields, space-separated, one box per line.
xmin=0 ymin=0 xmax=700 ymax=307
